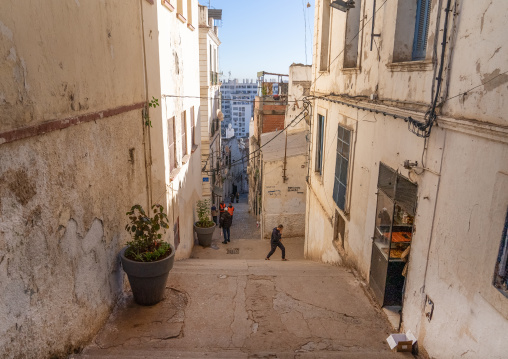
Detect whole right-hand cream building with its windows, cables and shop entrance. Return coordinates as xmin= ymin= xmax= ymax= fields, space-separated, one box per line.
xmin=305 ymin=0 xmax=508 ymax=358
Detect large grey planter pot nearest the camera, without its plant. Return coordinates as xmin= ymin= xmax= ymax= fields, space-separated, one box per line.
xmin=120 ymin=244 xmax=175 ymax=305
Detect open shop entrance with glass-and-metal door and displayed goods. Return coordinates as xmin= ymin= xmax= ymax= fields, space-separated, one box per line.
xmin=369 ymin=163 xmax=418 ymax=307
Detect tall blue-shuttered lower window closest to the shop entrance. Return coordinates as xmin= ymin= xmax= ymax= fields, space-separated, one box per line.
xmin=333 ymin=125 xmax=351 ymax=211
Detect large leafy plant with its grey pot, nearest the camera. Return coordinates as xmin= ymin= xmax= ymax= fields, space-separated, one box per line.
xmin=120 ymin=204 xmax=175 ymax=305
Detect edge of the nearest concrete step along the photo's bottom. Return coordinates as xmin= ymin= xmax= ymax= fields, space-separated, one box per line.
xmin=68 ymin=348 xmax=406 ymax=359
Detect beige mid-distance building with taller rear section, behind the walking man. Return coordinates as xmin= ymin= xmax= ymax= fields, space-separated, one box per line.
xmin=253 ymin=64 xmax=311 ymax=238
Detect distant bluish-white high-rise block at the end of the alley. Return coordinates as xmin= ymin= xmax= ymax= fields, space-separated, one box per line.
xmin=221 ymin=79 xmax=258 ymax=137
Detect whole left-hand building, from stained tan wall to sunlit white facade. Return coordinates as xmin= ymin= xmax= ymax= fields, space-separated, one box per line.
xmin=0 ymin=0 xmax=206 ymax=358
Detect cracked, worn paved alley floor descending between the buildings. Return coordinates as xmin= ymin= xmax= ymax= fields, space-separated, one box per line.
xmin=71 ymin=195 xmax=412 ymax=359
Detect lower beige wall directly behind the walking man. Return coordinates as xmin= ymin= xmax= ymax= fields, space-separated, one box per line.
xmin=261 ymin=155 xmax=307 ymax=238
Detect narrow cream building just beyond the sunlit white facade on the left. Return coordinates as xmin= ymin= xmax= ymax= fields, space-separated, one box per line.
xmin=199 ymin=5 xmax=223 ymax=204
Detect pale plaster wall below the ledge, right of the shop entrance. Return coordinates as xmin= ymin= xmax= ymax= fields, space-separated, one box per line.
xmin=405 ymin=131 xmax=508 ymax=358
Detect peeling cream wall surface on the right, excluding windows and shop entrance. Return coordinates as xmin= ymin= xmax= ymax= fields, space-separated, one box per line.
xmin=305 ymin=0 xmax=508 ymax=358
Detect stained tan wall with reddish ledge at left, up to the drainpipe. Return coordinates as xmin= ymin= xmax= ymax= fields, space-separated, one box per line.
xmin=0 ymin=0 xmax=147 ymax=358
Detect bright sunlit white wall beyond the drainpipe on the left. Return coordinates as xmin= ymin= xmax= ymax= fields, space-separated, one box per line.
xmin=142 ymin=0 xmax=202 ymax=260
